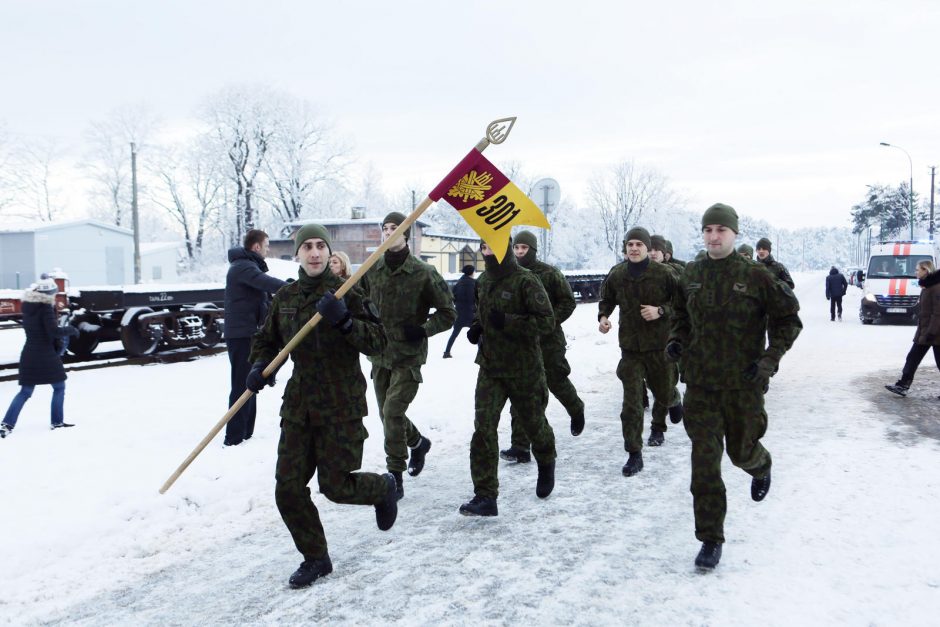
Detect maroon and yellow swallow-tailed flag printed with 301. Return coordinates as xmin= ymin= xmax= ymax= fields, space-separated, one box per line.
xmin=428 ymin=148 xmax=551 ymax=261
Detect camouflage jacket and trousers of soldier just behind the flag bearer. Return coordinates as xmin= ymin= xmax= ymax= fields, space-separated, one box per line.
xmin=367 ymin=254 xmax=457 ymax=472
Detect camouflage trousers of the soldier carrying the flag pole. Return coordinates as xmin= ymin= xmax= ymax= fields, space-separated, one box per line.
xmin=274 ymin=418 xmax=388 ymax=560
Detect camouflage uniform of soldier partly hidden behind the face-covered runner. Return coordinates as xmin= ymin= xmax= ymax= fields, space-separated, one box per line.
xmin=509 ymin=260 xmax=584 ymax=451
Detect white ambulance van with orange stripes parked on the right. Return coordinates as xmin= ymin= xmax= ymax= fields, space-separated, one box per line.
xmin=858 ymin=241 xmax=937 ymax=324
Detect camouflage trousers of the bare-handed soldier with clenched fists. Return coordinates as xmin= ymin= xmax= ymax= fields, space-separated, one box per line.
xmin=617 ymin=350 xmax=676 ymax=453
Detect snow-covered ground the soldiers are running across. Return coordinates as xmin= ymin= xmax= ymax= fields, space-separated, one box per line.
xmin=0 ymin=273 xmax=940 ymax=625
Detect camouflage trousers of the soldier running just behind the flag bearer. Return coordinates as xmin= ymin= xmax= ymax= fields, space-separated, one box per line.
xmin=372 ymin=366 xmax=422 ymax=472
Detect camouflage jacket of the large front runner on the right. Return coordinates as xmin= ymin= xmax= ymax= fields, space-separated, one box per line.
xmin=669 ymin=253 xmax=803 ymax=390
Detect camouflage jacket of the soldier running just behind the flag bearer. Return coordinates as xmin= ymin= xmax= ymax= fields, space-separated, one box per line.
xmin=366 ymin=255 xmax=457 ymax=368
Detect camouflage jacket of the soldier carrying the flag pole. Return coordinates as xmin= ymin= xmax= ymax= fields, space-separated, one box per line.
xmin=250 ymin=269 xmax=386 ymax=425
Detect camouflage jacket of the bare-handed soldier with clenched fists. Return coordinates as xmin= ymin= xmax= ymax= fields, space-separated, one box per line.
xmin=598 ymin=260 xmax=679 ymax=351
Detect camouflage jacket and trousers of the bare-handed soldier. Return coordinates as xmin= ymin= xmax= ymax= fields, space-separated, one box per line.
xmin=598 ymin=259 xmax=678 ymax=453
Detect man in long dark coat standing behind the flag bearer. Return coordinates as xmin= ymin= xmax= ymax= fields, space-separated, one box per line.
xmin=224 ymin=229 xmax=286 ymax=446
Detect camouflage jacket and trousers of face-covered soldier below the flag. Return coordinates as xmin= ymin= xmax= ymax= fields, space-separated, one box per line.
xmin=470 ymin=252 xmax=555 ymax=499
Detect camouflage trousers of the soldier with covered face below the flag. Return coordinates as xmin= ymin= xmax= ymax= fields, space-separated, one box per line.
xmin=470 ymin=368 xmax=555 ymax=499
